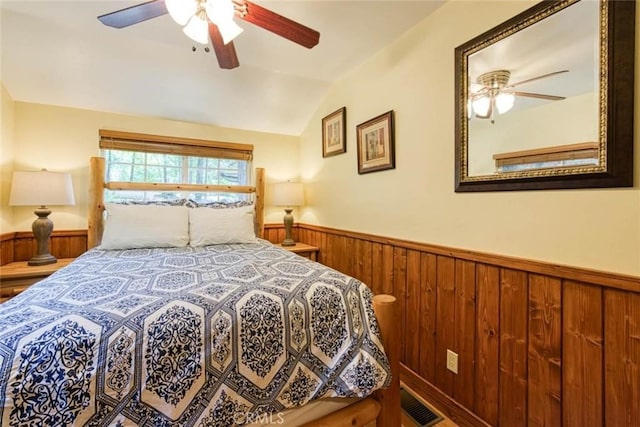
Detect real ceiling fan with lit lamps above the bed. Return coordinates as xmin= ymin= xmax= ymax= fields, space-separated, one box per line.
xmin=98 ymin=0 xmax=320 ymax=69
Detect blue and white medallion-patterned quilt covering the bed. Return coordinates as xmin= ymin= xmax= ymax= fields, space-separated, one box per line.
xmin=0 ymin=241 xmax=390 ymax=427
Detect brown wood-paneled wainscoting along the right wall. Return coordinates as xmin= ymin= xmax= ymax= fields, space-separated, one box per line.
xmin=265 ymin=224 xmax=640 ymax=427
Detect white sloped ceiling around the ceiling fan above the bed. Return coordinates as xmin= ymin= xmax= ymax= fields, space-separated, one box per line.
xmin=0 ymin=0 xmax=442 ymax=135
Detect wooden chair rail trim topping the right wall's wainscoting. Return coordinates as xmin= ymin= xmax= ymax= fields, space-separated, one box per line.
xmin=297 ymin=223 xmax=640 ymax=293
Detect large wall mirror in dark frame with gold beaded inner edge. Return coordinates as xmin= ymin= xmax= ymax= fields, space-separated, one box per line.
xmin=455 ymin=0 xmax=635 ymax=192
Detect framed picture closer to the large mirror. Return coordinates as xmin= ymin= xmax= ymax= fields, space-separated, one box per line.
xmin=357 ymin=110 xmax=396 ymax=174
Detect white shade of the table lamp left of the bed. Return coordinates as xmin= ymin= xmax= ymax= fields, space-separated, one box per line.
xmin=9 ymin=170 xmax=76 ymax=206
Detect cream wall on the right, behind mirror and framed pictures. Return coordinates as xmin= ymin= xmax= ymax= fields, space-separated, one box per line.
xmin=300 ymin=1 xmax=640 ymax=275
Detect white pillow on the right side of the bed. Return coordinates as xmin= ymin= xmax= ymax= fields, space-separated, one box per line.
xmin=189 ymin=206 xmax=257 ymax=246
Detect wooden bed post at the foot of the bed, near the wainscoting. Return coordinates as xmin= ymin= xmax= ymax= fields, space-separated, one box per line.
xmin=373 ymin=294 xmax=401 ymax=427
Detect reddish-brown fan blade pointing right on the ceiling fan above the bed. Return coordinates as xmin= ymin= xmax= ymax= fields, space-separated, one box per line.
xmin=234 ymin=0 xmax=320 ymax=49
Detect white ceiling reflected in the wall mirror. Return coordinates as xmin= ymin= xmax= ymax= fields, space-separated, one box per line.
xmin=468 ymin=1 xmax=600 ymax=111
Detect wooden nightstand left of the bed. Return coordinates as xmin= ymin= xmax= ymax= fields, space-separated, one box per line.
xmin=0 ymin=258 xmax=74 ymax=302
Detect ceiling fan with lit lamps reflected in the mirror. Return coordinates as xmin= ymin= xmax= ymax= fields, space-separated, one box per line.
xmin=468 ymin=70 xmax=569 ymax=123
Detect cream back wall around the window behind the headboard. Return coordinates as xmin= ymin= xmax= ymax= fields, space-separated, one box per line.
xmin=2 ymin=101 xmax=299 ymax=231
